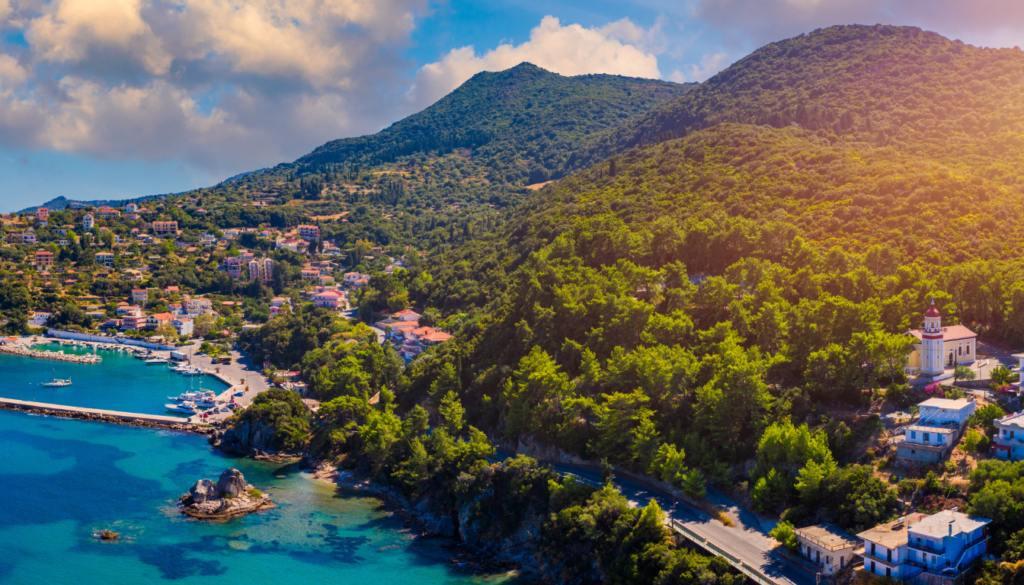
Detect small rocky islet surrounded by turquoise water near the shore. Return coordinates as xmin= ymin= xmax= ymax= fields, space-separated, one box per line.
xmin=178 ymin=468 xmax=274 ymax=519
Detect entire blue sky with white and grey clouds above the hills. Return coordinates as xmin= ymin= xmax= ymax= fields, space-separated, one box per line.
xmin=0 ymin=0 xmax=1024 ymax=211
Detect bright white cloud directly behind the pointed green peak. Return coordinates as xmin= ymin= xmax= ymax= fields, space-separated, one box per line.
xmin=409 ymin=16 xmax=660 ymax=108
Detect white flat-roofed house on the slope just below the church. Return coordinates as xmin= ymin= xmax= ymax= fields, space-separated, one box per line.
xmin=896 ymin=399 xmax=977 ymax=463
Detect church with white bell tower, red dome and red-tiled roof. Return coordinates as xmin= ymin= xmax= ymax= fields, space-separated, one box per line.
xmin=905 ymin=299 xmax=978 ymax=383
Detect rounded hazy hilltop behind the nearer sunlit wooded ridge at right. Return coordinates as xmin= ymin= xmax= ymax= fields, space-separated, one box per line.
xmin=580 ymin=26 xmax=1024 ymax=178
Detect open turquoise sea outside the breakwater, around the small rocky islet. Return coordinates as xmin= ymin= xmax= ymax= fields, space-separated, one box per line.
xmin=0 ymin=411 xmax=521 ymax=585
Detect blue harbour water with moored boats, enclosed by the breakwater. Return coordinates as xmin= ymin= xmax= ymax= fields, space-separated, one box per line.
xmin=0 ymin=343 xmax=227 ymax=417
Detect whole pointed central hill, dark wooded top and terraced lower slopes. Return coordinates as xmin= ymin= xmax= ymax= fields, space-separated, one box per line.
xmin=157 ymin=64 xmax=694 ymax=249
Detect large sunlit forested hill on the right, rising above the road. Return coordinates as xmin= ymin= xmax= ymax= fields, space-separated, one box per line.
xmin=370 ymin=27 xmax=1024 ymax=549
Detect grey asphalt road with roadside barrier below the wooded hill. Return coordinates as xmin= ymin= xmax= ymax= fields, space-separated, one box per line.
xmin=498 ymin=451 xmax=814 ymax=585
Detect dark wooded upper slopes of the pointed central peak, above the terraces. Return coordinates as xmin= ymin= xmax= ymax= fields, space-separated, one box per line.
xmin=295 ymin=62 xmax=695 ymax=183
